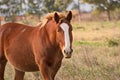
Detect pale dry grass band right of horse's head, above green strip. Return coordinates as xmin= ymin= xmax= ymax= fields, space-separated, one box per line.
xmin=74 ymin=22 xmax=120 ymax=41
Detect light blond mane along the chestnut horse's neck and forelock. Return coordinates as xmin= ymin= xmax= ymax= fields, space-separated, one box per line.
xmin=38 ymin=12 xmax=65 ymax=27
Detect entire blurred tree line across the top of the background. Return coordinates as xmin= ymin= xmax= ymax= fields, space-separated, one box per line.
xmin=0 ymin=0 xmax=120 ymax=21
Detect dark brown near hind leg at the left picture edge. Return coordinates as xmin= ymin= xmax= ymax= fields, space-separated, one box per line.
xmin=0 ymin=53 xmax=7 ymax=80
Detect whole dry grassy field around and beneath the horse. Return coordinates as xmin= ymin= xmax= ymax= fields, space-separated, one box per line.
xmin=5 ymin=21 xmax=120 ymax=80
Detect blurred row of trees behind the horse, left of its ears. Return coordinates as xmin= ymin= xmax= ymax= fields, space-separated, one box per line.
xmin=0 ymin=0 xmax=72 ymax=21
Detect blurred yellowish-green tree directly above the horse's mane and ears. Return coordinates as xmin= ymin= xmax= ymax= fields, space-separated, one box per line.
xmin=42 ymin=0 xmax=72 ymax=13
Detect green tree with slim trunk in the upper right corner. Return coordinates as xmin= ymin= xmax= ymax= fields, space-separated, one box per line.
xmin=83 ymin=0 xmax=120 ymax=20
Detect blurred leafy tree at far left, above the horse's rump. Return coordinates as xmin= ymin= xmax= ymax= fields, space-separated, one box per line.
xmin=0 ymin=0 xmax=23 ymax=22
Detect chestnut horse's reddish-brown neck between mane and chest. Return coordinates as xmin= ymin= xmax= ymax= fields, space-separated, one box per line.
xmin=38 ymin=24 xmax=58 ymax=47
